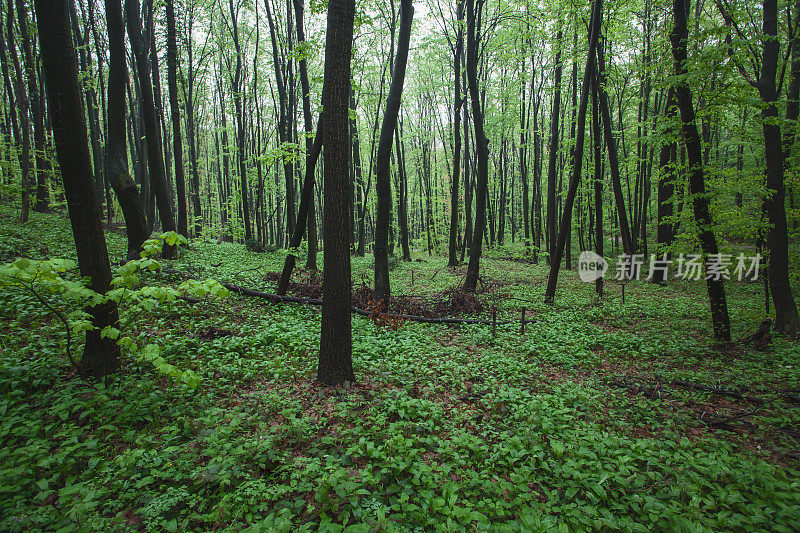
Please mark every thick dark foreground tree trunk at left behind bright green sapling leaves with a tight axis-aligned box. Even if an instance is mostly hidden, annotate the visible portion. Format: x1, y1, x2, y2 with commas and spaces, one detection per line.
35, 0, 119, 377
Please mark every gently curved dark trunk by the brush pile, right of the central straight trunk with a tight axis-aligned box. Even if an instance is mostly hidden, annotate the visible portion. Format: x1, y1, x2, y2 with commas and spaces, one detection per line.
374, 0, 414, 307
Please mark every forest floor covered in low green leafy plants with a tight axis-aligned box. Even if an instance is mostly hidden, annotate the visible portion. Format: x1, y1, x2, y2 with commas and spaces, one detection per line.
0, 207, 800, 532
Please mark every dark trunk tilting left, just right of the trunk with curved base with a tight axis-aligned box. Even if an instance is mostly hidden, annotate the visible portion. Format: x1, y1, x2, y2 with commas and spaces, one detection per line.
125, 0, 175, 259
